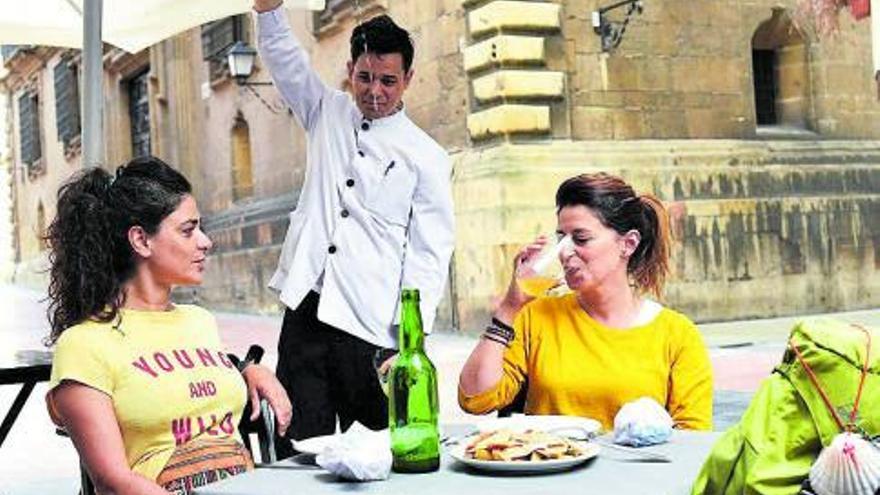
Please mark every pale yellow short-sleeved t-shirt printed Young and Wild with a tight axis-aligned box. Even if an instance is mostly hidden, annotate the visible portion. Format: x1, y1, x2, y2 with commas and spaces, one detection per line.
49, 305, 247, 480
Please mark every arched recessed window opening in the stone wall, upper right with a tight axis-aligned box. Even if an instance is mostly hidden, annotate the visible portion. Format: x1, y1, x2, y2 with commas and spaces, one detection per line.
752, 8, 810, 129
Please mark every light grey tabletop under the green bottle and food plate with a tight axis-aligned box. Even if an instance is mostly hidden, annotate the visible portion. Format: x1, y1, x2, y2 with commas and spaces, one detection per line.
196, 427, 721, 495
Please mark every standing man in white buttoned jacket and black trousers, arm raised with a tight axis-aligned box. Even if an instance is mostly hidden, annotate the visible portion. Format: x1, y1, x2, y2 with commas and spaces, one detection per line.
254, 0, 454, 451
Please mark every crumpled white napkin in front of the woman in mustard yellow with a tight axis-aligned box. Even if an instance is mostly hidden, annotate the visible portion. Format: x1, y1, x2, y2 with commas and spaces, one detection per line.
614, 397, 675, 447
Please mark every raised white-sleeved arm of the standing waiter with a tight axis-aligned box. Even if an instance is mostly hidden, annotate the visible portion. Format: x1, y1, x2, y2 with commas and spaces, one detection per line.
254, 0, 330, 130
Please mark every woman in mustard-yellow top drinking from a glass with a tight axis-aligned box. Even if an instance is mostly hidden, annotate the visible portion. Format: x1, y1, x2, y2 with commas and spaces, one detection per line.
459, 174, 712, 430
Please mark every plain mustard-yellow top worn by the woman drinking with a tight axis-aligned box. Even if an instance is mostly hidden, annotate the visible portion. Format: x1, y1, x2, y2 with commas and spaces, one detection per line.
459, 294, 712, 430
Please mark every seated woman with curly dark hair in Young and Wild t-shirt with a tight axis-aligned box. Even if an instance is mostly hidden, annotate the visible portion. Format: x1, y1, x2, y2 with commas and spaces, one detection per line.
46, 157, 290, 494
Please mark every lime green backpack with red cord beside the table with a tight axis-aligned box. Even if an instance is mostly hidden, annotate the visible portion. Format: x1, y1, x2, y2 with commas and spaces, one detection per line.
691, 318, 880, 495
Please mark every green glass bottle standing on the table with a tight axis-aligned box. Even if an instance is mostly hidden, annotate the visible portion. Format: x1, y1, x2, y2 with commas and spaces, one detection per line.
388, 289, 440, 473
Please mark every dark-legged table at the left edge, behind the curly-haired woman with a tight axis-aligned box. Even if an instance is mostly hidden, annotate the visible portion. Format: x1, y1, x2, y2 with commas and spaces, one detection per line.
0, 350, 52, 446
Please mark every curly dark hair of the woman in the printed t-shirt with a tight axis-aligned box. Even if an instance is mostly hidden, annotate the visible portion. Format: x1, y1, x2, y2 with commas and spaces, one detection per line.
45, 156, 192, 344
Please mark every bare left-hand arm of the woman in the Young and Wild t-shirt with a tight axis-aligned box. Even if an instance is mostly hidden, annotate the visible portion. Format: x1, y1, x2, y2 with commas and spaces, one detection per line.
49, 380, 168, 495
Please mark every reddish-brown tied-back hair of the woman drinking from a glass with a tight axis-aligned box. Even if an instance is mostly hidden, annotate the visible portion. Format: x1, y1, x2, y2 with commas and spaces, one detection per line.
556, 173, 672, 298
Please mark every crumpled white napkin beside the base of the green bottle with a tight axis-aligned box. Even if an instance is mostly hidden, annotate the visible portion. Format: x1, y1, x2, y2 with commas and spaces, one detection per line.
315, 422, 391, 481
